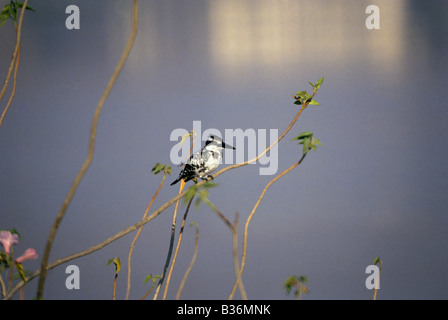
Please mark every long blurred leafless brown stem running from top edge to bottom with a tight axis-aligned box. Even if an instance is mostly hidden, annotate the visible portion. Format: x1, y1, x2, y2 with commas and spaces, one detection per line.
36, 0, 138, 299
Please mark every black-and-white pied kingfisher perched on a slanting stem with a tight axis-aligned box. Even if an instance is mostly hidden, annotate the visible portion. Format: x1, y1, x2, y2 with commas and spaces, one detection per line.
171, 136, 235, 185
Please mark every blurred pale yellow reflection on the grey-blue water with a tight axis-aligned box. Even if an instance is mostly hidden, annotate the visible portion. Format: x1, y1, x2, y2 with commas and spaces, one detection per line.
209, 0, 405, 76
